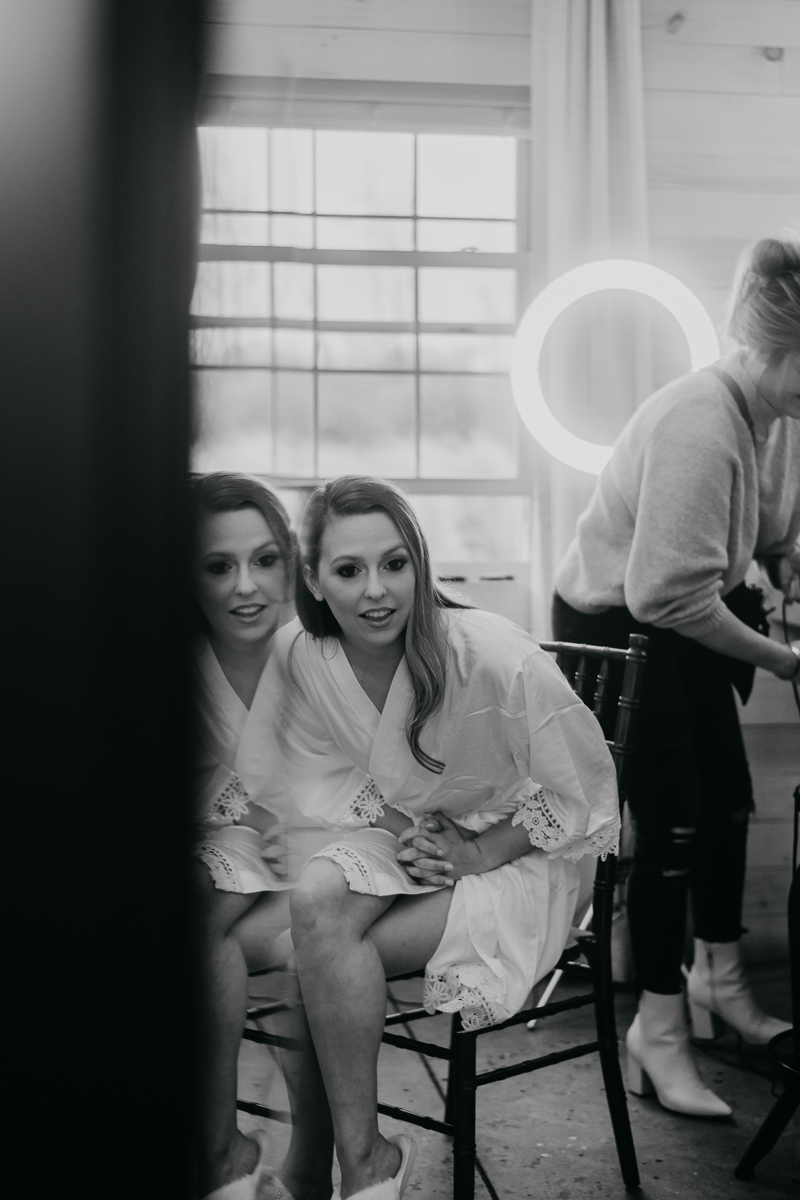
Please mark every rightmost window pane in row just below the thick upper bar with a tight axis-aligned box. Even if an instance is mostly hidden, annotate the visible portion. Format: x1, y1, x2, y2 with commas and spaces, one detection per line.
420, 266, 517, 325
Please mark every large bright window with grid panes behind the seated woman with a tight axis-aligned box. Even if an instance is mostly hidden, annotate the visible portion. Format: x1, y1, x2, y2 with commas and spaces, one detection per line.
192, 127, 528, 559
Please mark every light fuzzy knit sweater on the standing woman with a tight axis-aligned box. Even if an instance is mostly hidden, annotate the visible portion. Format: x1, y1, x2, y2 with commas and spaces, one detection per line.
555, 352, 800, 637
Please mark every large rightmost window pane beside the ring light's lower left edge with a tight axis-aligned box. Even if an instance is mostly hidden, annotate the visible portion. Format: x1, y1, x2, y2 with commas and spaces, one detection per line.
420, 376, 517, 479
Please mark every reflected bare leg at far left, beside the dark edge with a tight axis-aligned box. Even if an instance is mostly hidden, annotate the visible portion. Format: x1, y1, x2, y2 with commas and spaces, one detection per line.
196, 864, 288, 1196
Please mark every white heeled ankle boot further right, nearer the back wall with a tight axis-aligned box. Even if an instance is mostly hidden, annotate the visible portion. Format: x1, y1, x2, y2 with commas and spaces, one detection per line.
687, 937, 792, 1046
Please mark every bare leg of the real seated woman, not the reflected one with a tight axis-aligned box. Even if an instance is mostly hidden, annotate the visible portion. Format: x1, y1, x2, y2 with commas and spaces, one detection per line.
291, 858, 452, 1200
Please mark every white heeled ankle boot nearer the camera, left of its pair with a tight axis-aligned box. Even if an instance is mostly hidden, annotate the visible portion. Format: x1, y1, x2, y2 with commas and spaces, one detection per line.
625, 991, 732, 1117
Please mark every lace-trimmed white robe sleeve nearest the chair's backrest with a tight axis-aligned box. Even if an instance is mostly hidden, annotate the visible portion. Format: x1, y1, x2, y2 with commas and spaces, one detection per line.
510, 652, 620, 859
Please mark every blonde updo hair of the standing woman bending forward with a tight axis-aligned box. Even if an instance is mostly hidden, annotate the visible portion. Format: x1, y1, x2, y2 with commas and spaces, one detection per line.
727, 235, 800, 365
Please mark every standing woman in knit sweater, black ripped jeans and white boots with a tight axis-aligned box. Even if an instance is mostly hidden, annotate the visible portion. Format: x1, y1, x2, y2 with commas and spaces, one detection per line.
553, 239, 800, 1116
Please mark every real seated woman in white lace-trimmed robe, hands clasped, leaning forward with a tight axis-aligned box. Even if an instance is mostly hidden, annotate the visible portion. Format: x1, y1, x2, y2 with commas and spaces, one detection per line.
263, 478, 619, 1200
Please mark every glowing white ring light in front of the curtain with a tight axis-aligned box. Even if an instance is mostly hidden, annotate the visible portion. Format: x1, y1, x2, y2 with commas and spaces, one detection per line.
511, 258, 720, 475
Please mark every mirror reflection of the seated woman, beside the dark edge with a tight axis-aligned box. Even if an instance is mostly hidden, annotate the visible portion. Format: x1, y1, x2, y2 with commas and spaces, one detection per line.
192, 474, 330, 1200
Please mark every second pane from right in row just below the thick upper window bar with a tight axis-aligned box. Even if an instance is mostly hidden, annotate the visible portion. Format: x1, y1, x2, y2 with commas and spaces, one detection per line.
317, 266, 414, 320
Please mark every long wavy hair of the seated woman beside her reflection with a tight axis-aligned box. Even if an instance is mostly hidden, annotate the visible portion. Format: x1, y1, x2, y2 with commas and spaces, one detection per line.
295, 475, 469, 774
